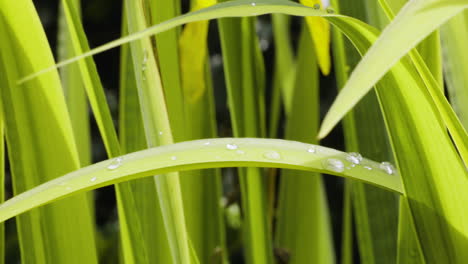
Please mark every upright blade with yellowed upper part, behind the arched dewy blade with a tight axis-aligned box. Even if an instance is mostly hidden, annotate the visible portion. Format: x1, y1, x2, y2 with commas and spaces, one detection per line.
176, 0, 228, 263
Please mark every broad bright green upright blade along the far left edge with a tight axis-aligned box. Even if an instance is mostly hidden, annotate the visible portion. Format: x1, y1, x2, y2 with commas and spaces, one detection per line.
0, 1, 97, 263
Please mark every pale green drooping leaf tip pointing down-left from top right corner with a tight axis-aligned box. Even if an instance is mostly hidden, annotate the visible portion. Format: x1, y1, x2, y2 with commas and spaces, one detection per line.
319, 0, 468, 138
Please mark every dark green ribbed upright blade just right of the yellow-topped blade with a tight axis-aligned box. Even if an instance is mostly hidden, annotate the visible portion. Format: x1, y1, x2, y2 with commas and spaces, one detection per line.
219, 8, 273, 263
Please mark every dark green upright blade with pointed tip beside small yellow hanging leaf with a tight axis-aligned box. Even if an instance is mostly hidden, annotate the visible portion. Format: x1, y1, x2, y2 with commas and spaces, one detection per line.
275, 25, 335, 264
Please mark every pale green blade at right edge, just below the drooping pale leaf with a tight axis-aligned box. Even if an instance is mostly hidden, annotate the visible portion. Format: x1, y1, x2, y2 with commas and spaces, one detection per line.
441, 11, 468, 129
